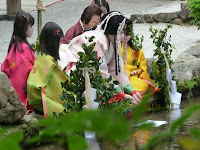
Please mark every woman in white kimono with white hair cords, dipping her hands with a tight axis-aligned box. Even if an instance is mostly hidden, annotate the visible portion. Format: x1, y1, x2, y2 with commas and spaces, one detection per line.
58, 11, 141, 104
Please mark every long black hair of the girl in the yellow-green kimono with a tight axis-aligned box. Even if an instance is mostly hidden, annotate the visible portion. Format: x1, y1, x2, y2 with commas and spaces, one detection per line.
39, 22, 64, 61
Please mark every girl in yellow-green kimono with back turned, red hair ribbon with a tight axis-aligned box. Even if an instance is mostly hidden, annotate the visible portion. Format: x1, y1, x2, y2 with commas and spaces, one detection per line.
27, 22, 67, 118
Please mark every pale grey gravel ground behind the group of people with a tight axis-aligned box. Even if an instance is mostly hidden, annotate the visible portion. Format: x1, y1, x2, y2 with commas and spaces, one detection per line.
0, 0, 200, 62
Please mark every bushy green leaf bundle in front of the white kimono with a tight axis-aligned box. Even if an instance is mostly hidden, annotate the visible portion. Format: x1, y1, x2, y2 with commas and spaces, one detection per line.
60, 36, 132, 114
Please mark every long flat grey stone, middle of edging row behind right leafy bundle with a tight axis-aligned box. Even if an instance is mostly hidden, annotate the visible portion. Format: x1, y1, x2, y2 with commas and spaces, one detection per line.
153, 12, 178, 23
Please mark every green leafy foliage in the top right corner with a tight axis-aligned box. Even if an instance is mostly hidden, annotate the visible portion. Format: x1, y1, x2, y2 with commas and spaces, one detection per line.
187, 0, 200, 30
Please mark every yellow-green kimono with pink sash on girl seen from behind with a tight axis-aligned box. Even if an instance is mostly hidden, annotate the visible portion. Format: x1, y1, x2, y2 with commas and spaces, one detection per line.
27, 54, 66, 117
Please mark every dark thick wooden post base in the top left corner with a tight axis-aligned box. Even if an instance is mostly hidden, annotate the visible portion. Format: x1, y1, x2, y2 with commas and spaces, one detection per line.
6, 0, 21, 15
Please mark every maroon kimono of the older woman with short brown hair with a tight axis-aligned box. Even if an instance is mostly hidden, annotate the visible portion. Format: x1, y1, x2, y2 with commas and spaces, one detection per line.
61, 20, 84, 44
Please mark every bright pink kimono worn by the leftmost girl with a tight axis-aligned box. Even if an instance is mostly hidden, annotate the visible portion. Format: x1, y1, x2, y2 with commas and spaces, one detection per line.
1, 42, 36, 113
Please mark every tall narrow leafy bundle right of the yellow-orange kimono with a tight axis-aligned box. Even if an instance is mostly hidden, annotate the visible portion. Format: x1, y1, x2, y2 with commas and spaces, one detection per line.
149, 25, 173, 106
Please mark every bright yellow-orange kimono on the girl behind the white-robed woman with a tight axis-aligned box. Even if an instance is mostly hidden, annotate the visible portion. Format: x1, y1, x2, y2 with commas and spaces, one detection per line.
121, 44, 155, 94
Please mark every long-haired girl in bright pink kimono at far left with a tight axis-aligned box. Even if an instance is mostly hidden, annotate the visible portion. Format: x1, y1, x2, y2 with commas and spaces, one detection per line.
1, 11, 36, 114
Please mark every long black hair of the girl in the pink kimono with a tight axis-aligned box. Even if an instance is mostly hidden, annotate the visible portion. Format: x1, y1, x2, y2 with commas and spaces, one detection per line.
8, 11, 34, 53
